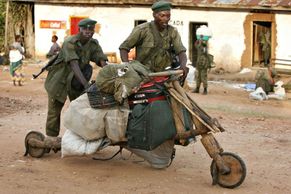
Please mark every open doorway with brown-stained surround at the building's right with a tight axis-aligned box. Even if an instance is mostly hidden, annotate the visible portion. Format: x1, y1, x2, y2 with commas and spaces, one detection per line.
252, 21, 273, 66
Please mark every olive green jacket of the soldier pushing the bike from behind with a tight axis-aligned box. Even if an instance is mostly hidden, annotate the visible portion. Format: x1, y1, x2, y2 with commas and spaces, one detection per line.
45, 34, 107, 102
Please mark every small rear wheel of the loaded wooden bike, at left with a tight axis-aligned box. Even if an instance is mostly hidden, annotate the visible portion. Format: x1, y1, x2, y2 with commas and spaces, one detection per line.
24, 131, 46, 158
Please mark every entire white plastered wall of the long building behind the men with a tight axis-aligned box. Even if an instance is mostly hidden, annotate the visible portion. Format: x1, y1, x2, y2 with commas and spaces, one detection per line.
35, 5, 280, 72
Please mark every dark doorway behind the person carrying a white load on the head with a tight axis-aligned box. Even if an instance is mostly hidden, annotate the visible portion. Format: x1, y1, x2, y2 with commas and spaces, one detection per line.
189, 22, 208, 67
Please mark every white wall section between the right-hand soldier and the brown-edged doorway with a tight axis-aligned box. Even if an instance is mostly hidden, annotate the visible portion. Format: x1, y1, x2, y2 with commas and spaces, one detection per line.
172, 10, 247, 71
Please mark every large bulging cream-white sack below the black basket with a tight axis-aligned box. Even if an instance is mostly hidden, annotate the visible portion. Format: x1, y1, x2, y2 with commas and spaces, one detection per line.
64, 93, 108, 140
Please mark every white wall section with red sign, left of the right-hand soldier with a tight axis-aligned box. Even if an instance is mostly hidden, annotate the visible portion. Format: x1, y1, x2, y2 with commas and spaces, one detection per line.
35, 5, 152, 56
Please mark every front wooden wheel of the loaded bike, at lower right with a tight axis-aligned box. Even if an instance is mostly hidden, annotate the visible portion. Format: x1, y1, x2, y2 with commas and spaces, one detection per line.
210, 152, 247, 189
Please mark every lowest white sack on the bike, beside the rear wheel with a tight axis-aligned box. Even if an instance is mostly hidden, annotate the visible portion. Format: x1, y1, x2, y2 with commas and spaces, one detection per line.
61, 130, 110, 157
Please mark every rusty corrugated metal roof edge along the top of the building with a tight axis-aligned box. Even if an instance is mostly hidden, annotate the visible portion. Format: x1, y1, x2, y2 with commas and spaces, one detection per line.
12, 0, 291, 12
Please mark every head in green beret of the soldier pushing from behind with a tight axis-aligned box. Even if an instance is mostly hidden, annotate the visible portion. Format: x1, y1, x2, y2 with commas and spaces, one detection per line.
78, 18, 97, 42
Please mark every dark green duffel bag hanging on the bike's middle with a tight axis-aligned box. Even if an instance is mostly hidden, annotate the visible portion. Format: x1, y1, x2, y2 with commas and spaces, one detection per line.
127, 100, 176, 151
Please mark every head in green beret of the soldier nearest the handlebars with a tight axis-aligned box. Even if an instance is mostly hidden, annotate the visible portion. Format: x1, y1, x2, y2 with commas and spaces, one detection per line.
152, 0, 172, 31
